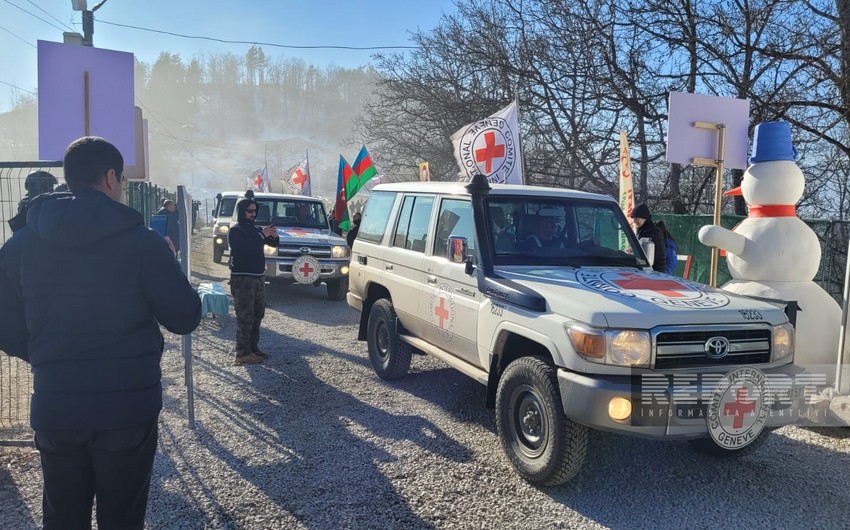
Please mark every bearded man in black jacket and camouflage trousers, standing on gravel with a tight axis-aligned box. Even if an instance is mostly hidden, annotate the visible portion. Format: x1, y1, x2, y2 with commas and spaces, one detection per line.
227, 197, 279, 366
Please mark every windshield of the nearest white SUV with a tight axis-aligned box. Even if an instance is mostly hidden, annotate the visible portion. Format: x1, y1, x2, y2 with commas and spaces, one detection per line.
487, 196, 647, 267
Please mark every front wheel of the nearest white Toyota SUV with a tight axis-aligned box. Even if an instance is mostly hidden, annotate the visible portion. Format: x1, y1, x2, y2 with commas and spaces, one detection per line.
496, 357, 588, 486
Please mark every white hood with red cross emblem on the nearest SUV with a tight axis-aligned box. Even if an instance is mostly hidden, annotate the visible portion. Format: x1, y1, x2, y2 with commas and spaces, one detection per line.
496, 267, 787, 329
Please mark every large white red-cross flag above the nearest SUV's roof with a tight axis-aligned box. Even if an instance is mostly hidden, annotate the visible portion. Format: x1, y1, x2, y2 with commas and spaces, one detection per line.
452, 102, 523, 184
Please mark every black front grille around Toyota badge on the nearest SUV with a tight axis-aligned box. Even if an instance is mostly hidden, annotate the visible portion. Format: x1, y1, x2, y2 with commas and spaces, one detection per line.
655, 328, 771, 370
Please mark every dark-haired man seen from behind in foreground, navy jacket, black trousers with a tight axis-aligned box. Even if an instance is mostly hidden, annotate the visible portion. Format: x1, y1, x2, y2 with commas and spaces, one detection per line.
0, 137, 201, 529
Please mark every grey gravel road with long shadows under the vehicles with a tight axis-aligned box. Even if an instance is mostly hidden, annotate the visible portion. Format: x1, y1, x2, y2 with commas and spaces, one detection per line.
0, 229, 850, 530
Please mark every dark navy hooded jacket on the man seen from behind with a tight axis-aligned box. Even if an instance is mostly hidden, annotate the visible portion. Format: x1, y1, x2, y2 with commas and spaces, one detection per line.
0, 191, 201, 430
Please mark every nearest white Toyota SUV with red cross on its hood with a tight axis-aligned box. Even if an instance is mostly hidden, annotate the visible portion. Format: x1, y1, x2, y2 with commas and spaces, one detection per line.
347, 176, 810, 485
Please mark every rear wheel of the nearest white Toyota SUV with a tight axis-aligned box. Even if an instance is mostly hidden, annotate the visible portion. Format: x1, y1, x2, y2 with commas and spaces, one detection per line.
366, 298, 413, 381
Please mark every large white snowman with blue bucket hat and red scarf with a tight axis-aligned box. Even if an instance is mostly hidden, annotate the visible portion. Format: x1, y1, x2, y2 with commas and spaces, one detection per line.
699, 121, 841, 384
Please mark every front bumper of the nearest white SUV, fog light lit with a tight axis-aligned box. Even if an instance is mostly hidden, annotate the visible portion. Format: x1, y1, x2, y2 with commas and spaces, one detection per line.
558, 364, 814, 440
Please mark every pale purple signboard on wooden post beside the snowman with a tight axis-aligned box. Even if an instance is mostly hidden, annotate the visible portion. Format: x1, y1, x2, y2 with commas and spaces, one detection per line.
667, 92, 750, 169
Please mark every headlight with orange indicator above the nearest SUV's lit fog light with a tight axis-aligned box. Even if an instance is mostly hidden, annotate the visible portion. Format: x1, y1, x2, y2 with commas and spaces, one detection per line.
564, 322, 652, 366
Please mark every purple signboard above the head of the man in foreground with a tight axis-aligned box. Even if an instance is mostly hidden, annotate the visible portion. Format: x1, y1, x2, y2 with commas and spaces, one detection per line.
38, 40, 136, 165
